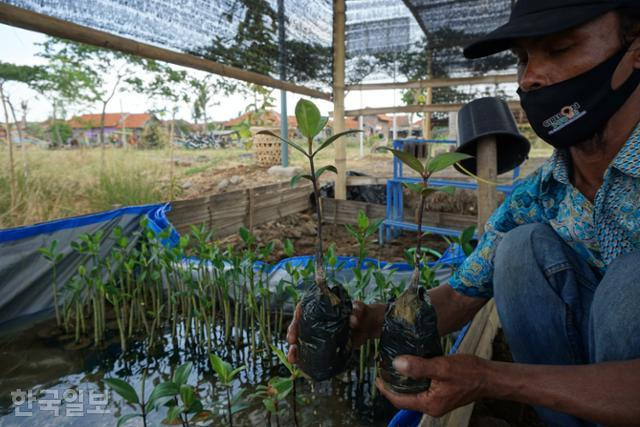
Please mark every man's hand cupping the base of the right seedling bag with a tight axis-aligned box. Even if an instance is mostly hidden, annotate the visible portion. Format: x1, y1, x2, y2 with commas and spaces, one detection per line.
376, 354, 488, 417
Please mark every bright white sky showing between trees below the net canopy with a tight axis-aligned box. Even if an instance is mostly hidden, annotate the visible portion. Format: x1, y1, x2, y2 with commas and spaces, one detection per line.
0, 24, 400, 121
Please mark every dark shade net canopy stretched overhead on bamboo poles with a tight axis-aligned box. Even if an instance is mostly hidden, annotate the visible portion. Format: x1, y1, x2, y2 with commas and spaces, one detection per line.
0, 0, 514, 90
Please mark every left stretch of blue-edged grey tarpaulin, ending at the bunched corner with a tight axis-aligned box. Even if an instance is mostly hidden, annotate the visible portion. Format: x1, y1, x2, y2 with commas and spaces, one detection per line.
0, 204, 177, 328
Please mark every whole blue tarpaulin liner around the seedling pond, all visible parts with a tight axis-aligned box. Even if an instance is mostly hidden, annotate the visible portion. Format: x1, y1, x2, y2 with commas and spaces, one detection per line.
0, 203, 466, 427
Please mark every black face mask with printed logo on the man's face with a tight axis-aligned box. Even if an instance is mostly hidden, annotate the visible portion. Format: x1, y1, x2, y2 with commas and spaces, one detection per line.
518, 48, 640, 149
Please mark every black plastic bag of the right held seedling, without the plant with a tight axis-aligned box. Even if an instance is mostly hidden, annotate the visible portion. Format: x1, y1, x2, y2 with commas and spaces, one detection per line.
380, 287, 442, 393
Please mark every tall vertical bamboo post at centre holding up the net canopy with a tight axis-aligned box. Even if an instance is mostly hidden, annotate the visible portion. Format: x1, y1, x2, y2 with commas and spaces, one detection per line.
333, 0, 347, 200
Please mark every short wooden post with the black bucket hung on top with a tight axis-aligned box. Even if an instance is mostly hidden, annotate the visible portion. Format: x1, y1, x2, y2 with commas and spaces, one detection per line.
476, 137, 498, 235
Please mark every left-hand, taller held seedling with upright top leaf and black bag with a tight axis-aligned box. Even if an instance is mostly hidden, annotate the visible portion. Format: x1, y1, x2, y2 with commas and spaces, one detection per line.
259, 100, 359, 381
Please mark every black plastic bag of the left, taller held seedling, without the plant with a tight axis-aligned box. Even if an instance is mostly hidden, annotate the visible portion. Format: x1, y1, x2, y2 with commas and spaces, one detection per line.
298, 285, 352, 381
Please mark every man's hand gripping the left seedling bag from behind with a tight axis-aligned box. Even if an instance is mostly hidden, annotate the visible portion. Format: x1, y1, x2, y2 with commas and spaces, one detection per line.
287, 301, 385, 363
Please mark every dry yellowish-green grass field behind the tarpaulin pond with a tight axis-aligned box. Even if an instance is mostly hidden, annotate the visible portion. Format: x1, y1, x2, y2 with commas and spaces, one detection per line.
0, 140, 376, 228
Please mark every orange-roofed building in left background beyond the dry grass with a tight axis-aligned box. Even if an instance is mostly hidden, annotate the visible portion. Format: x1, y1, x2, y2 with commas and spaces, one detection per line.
68, 113, 158, 144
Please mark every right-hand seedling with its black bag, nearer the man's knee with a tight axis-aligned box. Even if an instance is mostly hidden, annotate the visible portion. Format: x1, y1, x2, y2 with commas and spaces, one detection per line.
380, 147, 470, 393
